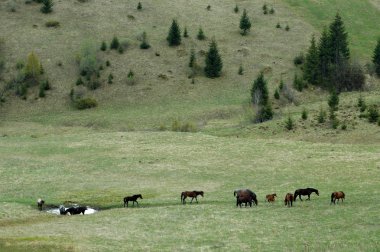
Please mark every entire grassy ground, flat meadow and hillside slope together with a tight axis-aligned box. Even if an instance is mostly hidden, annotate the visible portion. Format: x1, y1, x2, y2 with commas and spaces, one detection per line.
0, 0, 380, 251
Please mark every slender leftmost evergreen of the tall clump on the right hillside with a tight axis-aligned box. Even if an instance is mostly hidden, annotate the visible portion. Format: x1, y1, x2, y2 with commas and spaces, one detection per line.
303, 35, 320, 85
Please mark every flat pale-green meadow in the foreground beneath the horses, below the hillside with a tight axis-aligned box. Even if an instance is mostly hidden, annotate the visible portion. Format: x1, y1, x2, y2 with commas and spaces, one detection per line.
0, 128, 380, 251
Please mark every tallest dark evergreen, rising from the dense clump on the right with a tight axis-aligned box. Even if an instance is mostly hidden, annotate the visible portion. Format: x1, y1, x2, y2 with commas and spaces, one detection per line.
329, 13, 350, 66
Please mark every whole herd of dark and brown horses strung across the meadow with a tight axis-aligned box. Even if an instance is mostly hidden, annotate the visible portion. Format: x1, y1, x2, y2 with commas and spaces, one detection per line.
37, 187, 345, 215
